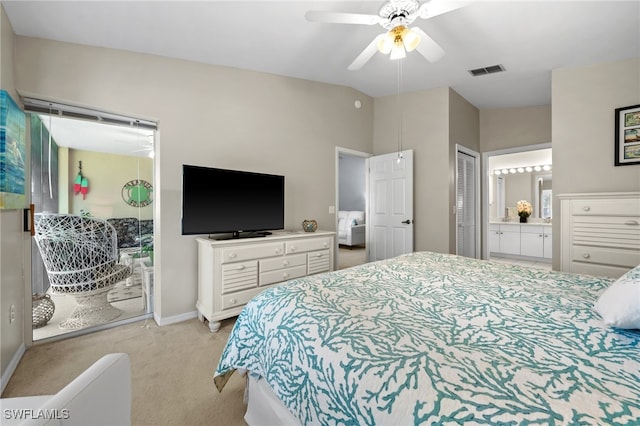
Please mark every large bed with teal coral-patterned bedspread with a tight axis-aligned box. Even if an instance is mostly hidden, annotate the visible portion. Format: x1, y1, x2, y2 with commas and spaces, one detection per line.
214, 252, 640, 425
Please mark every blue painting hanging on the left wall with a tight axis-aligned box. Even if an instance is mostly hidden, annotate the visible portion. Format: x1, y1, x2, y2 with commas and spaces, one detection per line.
0, 90, 27, 209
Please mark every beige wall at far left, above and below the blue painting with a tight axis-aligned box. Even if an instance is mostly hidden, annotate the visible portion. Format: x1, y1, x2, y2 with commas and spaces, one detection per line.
0, 7, 31, 389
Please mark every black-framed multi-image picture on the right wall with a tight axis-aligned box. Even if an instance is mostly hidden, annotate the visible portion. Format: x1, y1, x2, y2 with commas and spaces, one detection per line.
615, 105, 640, 166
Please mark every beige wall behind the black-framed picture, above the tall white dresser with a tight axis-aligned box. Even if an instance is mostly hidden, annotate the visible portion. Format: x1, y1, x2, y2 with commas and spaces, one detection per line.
551, 58, 640, 268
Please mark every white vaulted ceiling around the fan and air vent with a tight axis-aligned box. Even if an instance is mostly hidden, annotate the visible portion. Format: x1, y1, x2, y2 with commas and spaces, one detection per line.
2, 0, 640, 109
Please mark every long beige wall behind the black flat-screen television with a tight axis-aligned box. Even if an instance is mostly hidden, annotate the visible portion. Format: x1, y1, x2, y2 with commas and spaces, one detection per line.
15, 37, 373, 323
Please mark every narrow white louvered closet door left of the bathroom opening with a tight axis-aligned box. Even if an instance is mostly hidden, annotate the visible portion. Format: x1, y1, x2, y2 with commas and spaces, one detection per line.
456, 146, 480, 258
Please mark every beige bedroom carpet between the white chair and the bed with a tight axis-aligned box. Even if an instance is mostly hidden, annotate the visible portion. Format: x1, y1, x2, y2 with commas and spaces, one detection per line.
2, 318, 246, 426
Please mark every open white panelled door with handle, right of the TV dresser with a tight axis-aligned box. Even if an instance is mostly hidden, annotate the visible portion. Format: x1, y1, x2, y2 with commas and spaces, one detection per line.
367, 150, 413, 261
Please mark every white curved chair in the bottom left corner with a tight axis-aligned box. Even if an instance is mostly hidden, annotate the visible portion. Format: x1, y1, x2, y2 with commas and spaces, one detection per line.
0, 353, 131, 426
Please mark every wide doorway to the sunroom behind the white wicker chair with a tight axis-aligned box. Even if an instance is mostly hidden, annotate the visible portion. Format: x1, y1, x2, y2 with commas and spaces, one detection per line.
25, 99, 156, 341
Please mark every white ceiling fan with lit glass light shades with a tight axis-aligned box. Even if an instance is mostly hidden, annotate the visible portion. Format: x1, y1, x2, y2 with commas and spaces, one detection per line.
305, 0, 465, 71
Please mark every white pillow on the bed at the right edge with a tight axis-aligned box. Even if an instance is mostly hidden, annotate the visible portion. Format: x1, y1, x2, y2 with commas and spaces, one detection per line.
595, 265, 640, 329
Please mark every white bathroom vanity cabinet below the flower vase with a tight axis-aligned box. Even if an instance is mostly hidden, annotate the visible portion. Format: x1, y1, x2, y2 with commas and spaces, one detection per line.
489, 222, 553, 260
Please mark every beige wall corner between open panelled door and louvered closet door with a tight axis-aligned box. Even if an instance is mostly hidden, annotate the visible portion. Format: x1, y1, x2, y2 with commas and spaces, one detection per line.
373, 87, 479, 253
